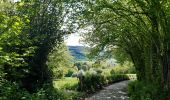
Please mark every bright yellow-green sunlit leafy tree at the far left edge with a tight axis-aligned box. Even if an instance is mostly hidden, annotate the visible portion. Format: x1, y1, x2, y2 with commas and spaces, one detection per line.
0, 1, 35, 82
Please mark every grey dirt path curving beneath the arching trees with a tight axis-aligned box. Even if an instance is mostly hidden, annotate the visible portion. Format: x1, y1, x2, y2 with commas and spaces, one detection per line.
85, 81, 130, 100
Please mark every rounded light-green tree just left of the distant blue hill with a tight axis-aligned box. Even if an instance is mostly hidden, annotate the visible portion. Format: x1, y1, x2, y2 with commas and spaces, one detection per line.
47, 43, 73, 78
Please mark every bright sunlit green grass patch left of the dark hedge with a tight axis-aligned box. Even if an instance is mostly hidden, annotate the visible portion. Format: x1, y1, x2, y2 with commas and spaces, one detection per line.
53, 77, 78, 90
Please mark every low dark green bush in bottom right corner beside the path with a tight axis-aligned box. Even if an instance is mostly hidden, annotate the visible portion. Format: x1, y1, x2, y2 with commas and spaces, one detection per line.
128, 81, 170, 100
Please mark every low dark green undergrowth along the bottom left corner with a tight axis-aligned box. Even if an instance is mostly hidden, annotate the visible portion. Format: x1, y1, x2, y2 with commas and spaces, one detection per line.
0, 80, 67, 100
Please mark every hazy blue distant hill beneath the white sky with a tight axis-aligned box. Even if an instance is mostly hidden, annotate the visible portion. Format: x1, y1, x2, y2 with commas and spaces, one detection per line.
68, 46, 87, 61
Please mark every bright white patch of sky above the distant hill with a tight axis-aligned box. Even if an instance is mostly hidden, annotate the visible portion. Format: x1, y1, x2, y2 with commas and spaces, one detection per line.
65, 34, 83, 46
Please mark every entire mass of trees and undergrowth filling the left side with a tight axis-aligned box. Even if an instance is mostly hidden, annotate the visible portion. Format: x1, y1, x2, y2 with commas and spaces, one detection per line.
0, 0, 73, 100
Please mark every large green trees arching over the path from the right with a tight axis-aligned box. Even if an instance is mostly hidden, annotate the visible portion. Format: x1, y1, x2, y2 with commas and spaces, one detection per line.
77, 0, 170, 89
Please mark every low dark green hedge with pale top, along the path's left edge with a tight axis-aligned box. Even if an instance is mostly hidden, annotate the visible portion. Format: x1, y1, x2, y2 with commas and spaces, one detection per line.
78, 70, 129, 93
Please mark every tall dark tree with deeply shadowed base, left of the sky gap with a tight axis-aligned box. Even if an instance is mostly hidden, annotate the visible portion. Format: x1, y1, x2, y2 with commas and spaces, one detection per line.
18, 0, 72, 91
